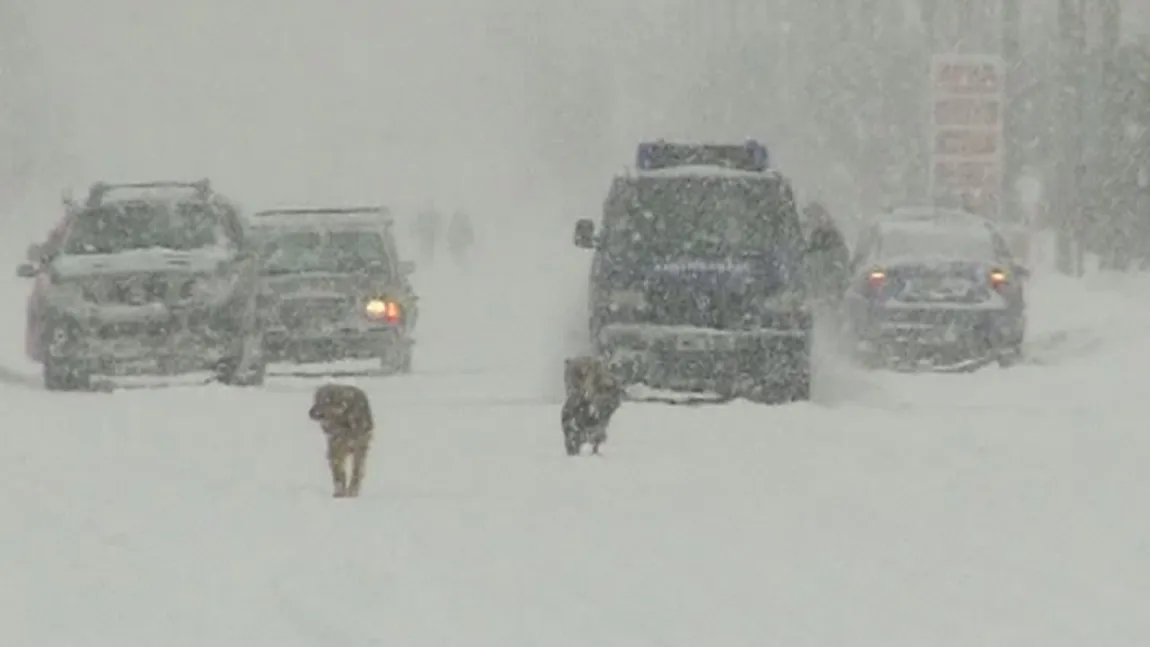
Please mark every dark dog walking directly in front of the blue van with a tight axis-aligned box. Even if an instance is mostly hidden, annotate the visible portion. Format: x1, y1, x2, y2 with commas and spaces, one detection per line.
560, 356, 623, 456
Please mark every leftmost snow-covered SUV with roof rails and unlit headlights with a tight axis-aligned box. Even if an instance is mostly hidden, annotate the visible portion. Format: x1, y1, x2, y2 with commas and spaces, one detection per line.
17, 180, 263, 390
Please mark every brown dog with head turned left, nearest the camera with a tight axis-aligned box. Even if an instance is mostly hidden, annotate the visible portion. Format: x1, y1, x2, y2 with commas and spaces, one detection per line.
307, 384, 375, 498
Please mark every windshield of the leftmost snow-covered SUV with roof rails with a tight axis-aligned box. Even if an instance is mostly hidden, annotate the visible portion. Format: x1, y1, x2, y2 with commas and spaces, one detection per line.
63, 202, 228, 255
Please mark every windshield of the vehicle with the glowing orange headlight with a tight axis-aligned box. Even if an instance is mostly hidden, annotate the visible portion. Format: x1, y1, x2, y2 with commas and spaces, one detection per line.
262, 231, 388, 275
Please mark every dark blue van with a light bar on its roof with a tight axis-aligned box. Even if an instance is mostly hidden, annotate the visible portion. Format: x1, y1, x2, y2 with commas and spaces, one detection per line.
575, 141, 812, 401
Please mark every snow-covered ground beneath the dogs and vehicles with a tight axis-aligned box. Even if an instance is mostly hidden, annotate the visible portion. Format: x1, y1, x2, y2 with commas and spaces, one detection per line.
0, 231, 1150, 647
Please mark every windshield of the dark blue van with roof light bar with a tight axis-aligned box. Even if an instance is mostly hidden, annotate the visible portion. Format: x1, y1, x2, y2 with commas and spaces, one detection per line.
604, 176, 802, 257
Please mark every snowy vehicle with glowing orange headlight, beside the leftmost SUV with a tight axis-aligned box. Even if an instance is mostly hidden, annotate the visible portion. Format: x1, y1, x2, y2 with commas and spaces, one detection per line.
251, 207, 419, 372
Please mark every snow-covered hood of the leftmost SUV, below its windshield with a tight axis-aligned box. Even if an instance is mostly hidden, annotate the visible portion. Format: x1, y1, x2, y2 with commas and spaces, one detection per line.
52, 249, 232, 278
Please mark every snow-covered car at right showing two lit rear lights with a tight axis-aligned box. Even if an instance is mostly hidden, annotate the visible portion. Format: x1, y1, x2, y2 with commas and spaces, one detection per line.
844, 209, 1029, 365
